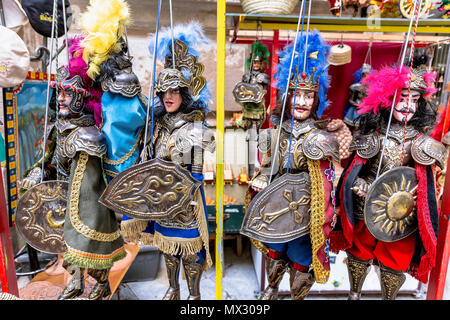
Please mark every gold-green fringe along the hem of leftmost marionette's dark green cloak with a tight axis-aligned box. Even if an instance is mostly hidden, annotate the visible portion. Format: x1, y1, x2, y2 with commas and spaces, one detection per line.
63, 247, 127, 270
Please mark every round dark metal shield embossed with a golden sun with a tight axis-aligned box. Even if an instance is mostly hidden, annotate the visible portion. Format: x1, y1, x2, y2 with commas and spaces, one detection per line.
364, 167, 418, 242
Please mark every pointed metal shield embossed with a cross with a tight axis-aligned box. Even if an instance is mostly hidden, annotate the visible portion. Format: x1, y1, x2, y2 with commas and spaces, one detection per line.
241, 172, 311, 243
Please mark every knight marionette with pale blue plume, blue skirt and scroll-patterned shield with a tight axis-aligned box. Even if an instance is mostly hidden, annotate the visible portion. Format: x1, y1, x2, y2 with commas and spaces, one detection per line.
102, 23, 215, 300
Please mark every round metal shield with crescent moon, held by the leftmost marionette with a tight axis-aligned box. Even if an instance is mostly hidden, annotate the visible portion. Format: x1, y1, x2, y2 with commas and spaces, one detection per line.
15, 180, 69, 254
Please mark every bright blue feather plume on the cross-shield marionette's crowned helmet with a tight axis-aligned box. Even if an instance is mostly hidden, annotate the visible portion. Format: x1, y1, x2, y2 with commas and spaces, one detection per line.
274, 30, 330, 117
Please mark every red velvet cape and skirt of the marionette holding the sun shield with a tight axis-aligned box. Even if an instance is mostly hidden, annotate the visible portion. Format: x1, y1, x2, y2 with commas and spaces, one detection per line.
330, 153, 439, 283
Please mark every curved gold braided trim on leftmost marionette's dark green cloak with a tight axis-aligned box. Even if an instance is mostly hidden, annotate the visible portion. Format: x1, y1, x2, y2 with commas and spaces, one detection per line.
69, 152, 120, 242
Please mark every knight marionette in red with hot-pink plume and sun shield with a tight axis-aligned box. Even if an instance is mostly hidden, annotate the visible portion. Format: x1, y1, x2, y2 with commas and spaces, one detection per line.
331, 60, 445, 300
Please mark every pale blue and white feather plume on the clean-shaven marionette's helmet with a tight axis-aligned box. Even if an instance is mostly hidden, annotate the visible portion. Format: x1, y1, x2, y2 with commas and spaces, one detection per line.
148, 21, 212, 113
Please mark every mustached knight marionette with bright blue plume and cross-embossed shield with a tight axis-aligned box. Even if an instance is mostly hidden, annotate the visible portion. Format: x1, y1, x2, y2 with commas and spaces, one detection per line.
241, 32, 339, 299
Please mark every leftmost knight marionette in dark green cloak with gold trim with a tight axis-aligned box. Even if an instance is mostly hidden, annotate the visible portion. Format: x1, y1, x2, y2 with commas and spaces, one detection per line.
18, 38, 126, 300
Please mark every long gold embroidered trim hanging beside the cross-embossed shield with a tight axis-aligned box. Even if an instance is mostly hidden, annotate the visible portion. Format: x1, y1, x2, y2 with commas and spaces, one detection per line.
307, 158, 330, 283
